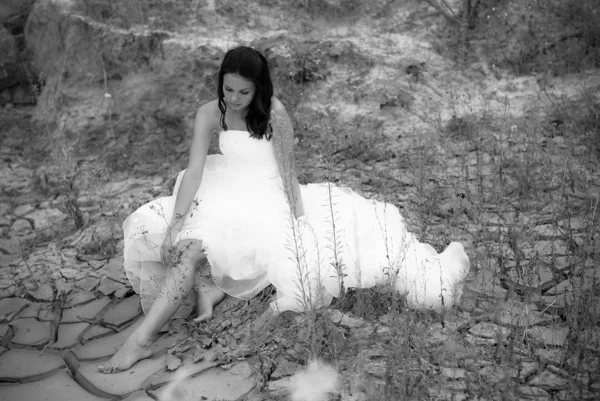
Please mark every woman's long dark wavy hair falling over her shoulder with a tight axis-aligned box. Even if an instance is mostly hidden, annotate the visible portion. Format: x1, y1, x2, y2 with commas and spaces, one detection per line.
217, 46, 273, 140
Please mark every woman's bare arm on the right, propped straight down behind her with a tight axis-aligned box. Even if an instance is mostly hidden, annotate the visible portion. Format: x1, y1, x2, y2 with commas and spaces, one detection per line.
271, 98, 304, 218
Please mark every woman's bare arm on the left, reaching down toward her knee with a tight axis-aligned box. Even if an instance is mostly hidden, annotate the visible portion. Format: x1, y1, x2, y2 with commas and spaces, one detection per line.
169, 104, 214, 234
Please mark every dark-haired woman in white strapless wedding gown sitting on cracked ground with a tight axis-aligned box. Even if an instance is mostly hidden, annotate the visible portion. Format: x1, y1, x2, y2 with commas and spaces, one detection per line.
99, 46, 469, 373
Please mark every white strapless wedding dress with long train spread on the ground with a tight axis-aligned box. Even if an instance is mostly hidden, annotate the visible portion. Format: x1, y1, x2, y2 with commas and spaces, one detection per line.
123, 130, 469, 314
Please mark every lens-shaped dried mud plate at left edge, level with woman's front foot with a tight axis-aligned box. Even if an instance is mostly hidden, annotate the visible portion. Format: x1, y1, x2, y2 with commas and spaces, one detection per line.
0, 348, 65, 382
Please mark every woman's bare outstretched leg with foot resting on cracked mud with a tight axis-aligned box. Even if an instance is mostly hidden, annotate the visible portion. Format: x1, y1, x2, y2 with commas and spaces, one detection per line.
99, 240, 206, 373
